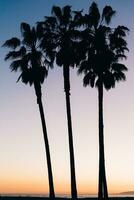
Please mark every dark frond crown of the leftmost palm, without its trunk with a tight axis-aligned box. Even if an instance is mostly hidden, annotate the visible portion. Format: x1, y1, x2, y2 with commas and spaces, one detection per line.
3, 23, 48, 86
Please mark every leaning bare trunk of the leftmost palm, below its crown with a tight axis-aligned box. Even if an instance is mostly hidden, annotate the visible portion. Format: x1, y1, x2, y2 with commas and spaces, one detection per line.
34, 83, 55, 199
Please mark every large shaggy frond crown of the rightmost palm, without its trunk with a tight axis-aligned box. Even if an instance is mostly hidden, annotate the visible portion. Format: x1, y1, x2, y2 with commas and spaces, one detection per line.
78, 3, 128, 90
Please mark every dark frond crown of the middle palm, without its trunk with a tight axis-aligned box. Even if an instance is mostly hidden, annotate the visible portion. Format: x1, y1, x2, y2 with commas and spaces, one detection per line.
39, 5, 79, 69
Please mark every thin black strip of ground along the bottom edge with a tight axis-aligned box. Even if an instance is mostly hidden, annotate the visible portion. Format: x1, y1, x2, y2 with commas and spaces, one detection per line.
0, 196, 134, 200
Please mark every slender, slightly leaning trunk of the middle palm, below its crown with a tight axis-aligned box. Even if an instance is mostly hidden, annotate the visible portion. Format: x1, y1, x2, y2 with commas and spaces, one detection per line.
63, 66, 77, 199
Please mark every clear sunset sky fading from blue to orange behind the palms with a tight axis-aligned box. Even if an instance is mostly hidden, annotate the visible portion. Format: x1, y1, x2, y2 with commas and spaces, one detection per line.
0, 0, 134, 194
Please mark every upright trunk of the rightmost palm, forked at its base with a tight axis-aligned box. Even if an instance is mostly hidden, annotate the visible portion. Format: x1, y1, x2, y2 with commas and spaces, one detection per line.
98, 83, 108, 199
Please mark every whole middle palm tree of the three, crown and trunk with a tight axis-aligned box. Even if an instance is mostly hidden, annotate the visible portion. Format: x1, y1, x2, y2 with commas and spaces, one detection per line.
40, 5, 78, 199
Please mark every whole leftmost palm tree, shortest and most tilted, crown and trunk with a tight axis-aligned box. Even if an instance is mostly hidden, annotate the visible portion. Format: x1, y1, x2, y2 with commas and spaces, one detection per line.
3, 23, 55, 198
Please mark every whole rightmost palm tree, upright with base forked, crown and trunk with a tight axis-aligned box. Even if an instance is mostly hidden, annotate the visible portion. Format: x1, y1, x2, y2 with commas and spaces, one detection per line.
78, 2, 128, 199
